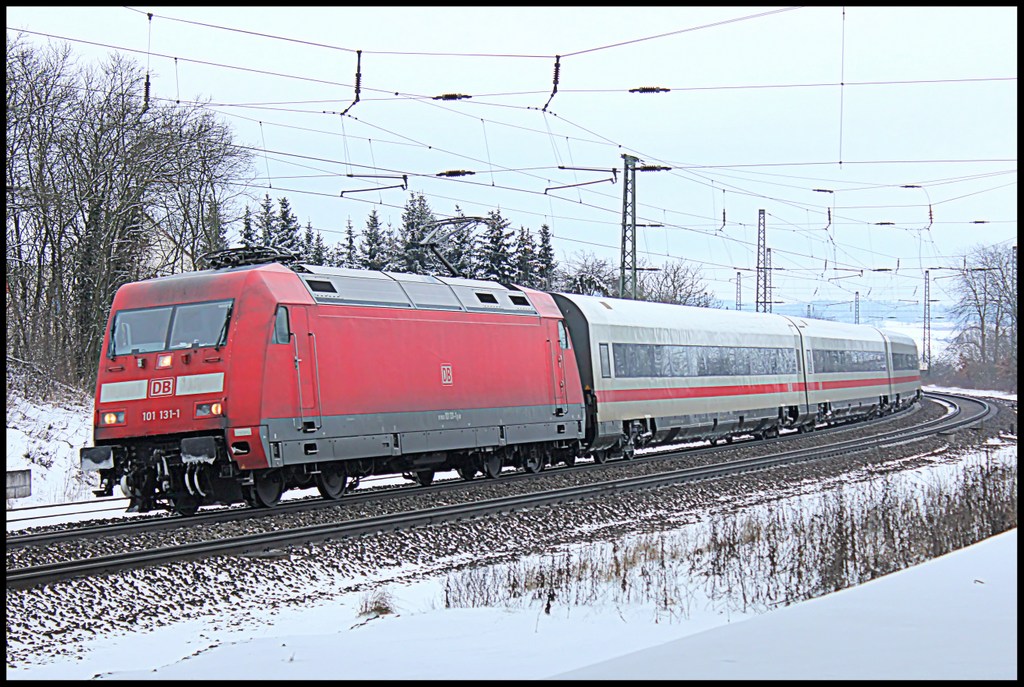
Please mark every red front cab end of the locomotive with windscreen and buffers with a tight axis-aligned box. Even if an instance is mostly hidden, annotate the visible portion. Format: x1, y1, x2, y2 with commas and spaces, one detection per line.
80, 265, 311, 514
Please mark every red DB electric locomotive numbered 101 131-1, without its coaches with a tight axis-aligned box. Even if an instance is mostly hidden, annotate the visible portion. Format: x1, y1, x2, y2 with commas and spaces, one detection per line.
81, 249, 584, 514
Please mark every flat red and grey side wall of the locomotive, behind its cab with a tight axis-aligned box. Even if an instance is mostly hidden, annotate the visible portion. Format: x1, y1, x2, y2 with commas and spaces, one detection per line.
261, 278, 583, 467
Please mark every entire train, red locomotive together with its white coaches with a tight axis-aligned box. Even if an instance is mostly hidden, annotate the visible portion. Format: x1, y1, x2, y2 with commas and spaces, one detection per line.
81, 250, 921, 514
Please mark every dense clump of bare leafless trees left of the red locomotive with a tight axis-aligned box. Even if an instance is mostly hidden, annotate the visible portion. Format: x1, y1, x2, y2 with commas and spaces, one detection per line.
6, 36, 256, 393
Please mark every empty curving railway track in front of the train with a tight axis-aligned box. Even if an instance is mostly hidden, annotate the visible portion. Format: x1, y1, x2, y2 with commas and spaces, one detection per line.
7, 393, 996, 588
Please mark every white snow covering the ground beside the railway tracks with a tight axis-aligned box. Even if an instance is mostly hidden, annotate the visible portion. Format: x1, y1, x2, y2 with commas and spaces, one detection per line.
7, 387, 1017, 680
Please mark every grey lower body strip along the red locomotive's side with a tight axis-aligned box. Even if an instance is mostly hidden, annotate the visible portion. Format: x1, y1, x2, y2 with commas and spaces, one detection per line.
263, 405, 584, 467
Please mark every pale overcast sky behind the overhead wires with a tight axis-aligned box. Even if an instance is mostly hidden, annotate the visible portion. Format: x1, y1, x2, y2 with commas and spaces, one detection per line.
7, 6, 1018, 319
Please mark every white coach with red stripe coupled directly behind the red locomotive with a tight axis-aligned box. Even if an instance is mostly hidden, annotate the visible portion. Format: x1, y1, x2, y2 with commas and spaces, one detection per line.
555, 294, 814, 460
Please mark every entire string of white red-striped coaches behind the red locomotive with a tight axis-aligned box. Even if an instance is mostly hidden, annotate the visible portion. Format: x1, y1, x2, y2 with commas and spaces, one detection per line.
554, 294, 921, 460
